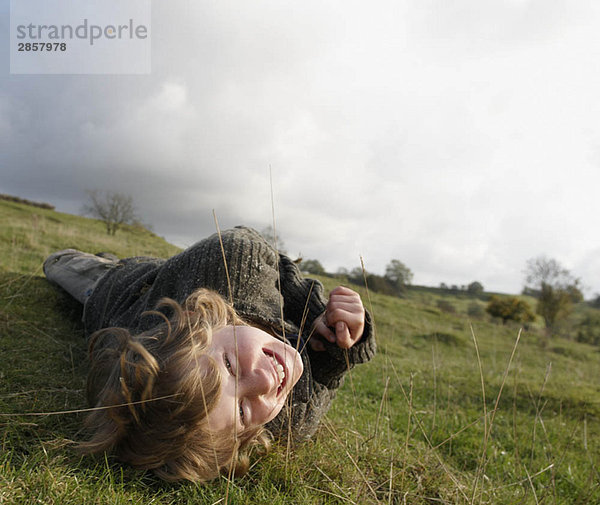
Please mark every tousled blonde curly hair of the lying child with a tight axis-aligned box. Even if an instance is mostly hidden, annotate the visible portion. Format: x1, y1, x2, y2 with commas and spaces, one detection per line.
79, 289, 269, 482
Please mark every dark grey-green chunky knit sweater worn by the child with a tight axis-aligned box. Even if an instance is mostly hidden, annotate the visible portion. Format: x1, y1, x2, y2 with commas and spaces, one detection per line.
84, 227, 375, 440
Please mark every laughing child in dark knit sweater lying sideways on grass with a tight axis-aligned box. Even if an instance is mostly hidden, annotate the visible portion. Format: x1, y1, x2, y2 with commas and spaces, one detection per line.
44, 227, 375, 481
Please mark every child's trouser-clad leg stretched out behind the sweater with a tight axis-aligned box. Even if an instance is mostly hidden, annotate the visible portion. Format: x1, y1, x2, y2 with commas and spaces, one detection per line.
44, 249, 116, 303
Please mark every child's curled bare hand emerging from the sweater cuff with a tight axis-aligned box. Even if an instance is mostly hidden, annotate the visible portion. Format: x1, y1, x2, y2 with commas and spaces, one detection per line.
310, 286, 365, 351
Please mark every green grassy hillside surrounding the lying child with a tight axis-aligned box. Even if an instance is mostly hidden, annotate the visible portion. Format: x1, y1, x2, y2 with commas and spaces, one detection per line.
0, 202, 600, 505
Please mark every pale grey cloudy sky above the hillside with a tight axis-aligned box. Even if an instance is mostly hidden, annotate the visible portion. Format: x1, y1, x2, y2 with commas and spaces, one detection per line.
0, 0, 600, 296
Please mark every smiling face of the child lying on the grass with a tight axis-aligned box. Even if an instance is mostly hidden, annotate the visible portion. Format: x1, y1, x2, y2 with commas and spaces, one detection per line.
208, 326, 303, 433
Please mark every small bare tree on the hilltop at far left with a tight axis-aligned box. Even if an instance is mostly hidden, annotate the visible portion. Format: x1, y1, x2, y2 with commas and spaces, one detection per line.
83, 190, 136, 235
